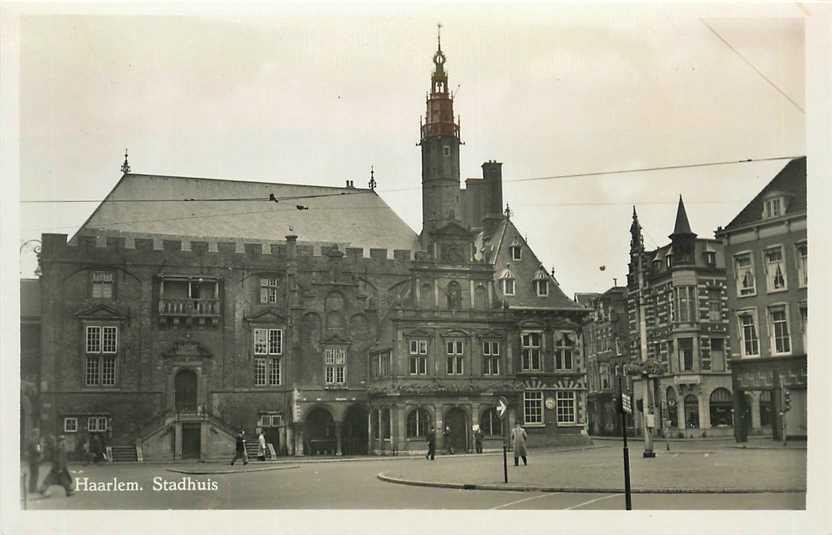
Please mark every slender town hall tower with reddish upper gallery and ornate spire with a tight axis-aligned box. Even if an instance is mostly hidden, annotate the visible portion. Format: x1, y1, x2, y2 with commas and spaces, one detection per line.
419, 26, 462, 241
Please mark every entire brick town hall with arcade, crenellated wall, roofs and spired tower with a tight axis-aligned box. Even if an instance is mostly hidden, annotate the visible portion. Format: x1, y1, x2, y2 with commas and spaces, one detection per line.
35, 36, 588, 460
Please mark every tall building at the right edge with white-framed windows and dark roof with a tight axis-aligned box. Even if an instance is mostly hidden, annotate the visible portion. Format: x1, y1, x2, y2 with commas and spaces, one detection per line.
717, 157, 809, 441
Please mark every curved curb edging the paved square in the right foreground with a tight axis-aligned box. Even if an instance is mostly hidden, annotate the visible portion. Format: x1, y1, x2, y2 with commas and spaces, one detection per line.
376, 472, 806, 494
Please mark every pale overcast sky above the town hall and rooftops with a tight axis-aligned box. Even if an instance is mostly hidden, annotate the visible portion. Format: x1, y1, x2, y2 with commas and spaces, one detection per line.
14, 4, 812, 296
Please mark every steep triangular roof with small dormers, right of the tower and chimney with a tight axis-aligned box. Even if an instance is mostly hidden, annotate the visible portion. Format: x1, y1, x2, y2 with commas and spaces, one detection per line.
476, 218, 584, 310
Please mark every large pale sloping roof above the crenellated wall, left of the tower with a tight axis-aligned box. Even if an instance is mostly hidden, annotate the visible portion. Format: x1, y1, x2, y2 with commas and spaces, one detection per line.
73, 174, 417, 250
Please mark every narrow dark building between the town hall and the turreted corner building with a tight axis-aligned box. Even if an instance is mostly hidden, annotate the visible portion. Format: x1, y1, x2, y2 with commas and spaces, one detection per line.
581, 286, 633, 436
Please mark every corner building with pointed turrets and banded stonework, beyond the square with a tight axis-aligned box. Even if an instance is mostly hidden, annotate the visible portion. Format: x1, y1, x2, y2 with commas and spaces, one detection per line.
627, 197, 733, 437
